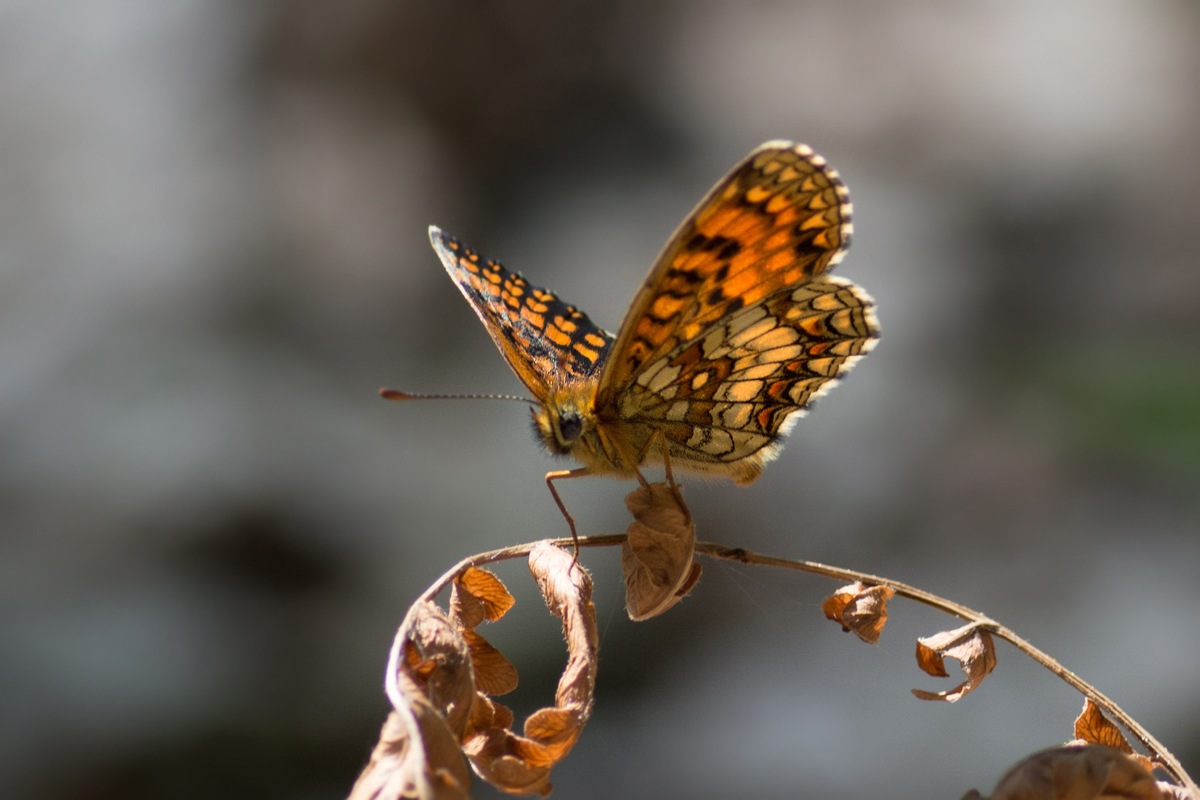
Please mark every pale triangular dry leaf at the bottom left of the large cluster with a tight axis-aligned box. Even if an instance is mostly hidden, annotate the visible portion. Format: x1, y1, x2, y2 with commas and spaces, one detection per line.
349, 675, 470, 800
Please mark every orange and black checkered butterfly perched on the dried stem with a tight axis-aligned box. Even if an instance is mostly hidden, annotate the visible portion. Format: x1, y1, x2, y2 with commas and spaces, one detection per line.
383, 142, 880, 541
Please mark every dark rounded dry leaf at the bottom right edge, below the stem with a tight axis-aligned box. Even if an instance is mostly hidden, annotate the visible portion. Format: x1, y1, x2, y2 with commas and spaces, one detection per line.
964, 745, 1166, 800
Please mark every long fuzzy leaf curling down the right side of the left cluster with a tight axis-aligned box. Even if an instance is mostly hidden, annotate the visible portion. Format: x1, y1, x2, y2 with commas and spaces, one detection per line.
463, 542, 599, 795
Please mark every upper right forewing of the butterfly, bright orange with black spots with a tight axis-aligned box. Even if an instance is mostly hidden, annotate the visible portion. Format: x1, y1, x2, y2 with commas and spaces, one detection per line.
598, 142, 851, 407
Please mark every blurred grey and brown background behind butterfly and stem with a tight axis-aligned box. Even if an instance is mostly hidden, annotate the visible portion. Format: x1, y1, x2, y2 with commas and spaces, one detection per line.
0, 0, 1200, 800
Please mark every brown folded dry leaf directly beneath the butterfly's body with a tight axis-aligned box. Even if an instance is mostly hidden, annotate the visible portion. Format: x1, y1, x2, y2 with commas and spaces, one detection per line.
620, 483, 701, 621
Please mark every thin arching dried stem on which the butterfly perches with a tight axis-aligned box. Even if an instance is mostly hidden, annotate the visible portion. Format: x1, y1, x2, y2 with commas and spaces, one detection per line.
386, 534, 1200, 796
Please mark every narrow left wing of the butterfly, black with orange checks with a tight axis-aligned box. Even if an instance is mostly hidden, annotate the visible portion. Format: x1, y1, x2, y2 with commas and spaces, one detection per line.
430, 225, 614, 402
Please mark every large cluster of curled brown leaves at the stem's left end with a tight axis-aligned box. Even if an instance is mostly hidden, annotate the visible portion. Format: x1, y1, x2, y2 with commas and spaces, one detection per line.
350, 542, 598, 800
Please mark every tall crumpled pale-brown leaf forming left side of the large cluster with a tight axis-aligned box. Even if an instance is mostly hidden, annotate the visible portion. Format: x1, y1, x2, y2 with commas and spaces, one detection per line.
350, 603, 475, 800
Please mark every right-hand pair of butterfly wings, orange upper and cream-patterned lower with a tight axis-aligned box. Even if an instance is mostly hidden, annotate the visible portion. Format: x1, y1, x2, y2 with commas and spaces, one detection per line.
596, 142, 878, 482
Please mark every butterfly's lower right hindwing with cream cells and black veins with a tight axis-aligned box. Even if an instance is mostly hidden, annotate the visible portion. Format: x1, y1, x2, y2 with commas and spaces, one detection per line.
618, 276, 878, 474
